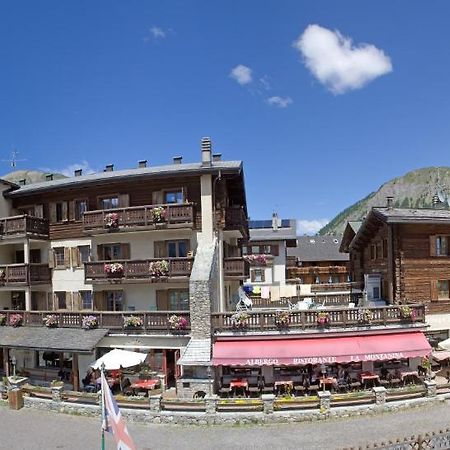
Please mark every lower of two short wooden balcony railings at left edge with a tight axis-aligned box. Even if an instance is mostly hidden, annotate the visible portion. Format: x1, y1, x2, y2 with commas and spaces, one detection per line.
0, 264, 52, 286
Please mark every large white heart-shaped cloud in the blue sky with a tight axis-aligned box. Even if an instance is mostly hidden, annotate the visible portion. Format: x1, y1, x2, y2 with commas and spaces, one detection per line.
293, 25, 392, 94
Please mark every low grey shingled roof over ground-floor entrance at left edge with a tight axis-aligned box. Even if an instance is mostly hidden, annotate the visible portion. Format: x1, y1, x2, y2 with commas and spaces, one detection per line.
0, 327, 108, 353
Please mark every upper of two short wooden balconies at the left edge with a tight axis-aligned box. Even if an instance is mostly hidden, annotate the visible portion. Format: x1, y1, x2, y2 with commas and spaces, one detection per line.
0, 214, 49, 239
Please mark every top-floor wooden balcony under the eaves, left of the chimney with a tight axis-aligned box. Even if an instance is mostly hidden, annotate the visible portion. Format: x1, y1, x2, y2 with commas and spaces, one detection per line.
83, 203, 195, 234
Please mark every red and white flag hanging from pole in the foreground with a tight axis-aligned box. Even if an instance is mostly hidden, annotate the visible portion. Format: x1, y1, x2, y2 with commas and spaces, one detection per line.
102, 372, 136, 450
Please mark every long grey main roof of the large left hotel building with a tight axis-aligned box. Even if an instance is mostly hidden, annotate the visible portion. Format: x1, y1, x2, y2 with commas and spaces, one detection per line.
8, 161, 242, 197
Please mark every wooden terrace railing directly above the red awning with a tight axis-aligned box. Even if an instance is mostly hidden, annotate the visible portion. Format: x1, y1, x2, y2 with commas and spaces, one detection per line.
211, 305, 425, 332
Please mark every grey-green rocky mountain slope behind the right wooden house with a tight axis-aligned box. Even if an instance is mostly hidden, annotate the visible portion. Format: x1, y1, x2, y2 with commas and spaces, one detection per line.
319, 167, 450, 234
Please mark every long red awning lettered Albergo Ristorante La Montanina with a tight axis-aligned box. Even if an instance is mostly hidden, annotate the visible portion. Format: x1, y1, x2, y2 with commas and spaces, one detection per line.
212, 331, 431, 366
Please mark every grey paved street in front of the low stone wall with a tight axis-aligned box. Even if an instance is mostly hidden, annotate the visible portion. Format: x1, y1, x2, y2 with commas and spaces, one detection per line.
0, 402, 450, 450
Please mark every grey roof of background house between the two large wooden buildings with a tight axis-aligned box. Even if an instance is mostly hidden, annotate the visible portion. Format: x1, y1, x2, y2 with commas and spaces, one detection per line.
288, 235, 349, 262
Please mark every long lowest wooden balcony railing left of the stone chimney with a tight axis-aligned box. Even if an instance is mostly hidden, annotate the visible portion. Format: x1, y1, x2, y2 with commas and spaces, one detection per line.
1, 310, 191, 333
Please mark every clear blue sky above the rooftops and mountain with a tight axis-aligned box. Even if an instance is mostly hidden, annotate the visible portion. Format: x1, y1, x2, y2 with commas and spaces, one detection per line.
0, 0, 450, 230
